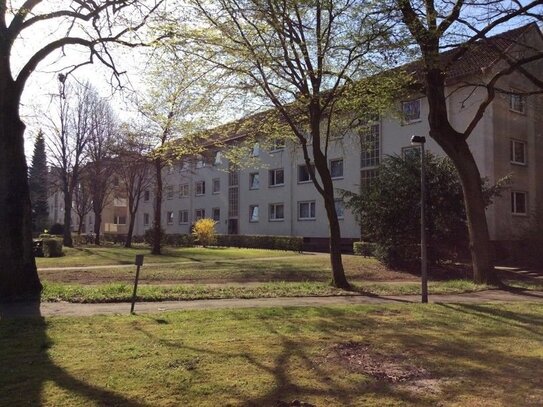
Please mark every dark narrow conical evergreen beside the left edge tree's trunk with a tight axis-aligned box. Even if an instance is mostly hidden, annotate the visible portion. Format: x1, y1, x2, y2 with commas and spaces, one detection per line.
28, 130, 49, 233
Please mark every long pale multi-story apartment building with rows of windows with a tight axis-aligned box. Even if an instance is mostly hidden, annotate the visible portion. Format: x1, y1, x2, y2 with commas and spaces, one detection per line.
131, 24, 543, 249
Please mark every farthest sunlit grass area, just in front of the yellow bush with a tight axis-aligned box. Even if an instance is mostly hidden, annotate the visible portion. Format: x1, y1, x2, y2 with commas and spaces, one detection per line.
36, 245, 298, 268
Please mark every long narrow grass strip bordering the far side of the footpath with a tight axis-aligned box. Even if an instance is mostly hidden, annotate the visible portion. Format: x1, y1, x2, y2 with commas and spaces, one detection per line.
42, 280, 491, 303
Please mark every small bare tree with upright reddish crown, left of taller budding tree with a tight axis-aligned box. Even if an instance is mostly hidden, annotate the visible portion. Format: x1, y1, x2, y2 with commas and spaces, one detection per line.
115, 131, 153, 247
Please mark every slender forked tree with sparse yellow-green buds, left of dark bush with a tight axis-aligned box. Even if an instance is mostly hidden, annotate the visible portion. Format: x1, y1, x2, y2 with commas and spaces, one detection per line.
172, 0, 406, 288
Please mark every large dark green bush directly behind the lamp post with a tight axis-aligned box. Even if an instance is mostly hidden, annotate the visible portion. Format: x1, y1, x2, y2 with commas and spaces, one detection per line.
344, 153, 499, 267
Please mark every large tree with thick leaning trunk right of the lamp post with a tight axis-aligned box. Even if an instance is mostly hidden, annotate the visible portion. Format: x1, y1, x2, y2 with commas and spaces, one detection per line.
389, 0, 543, 283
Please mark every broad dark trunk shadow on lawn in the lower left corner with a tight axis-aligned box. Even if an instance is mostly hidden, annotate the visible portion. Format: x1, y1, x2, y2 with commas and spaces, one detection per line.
0, 302, 149, 407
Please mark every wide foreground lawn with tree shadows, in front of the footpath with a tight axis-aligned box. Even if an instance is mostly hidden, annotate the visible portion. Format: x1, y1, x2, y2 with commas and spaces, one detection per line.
0, 304, 543, 406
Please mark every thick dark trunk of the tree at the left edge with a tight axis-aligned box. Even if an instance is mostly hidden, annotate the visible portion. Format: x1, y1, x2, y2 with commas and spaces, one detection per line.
0, 75, 42, 302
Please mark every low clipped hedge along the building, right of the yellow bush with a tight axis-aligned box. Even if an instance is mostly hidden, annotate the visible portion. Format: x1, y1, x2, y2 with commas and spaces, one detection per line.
215, 235, 304, 252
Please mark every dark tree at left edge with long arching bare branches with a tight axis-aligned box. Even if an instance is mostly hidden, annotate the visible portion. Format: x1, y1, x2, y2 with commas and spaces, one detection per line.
0, 0, 163, 300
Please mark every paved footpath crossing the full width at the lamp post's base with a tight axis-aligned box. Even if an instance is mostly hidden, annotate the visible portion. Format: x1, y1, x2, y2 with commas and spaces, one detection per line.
0, 290, 543, 317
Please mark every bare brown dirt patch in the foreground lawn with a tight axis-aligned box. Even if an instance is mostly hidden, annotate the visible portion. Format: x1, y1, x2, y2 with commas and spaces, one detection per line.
325, 342, 431, 383
